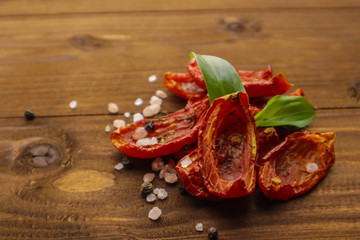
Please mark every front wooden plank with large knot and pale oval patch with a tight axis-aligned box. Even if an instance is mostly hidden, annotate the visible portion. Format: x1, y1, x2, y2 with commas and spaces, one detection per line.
0, 110, 360, 239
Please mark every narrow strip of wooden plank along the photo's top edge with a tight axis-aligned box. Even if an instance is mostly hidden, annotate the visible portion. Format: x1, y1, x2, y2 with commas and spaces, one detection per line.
0, 0, 360, 16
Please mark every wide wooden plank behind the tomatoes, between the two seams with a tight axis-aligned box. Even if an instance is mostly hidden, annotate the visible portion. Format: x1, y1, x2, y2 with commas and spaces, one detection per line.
0, 9, 360, 117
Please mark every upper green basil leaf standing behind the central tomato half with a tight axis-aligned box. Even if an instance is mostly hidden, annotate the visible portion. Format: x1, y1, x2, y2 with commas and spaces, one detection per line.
190, 52, 245, 102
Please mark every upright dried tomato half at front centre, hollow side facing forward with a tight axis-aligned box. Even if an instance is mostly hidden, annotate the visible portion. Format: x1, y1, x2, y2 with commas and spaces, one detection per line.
199, 92, 257, 198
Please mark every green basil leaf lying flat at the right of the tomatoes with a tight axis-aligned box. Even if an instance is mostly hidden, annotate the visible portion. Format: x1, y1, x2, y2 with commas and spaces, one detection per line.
255, 95, 315, 128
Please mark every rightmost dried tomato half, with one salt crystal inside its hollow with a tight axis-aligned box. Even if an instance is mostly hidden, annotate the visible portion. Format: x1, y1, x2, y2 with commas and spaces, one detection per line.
258, 132, 335, 200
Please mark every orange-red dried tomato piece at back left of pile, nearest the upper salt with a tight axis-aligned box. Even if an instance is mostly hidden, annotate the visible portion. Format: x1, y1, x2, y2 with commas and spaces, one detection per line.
163, 72, 206, 99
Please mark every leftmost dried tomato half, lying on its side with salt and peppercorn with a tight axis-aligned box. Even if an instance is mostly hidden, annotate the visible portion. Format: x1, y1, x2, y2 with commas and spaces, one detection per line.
110, 98, 209, 158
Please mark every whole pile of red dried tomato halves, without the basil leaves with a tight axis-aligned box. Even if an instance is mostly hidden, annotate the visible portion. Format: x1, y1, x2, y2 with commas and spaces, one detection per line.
111, 58, 335, 201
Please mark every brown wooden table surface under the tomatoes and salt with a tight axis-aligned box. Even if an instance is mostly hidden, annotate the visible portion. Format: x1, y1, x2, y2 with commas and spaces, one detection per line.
0, 0, 360, 239
